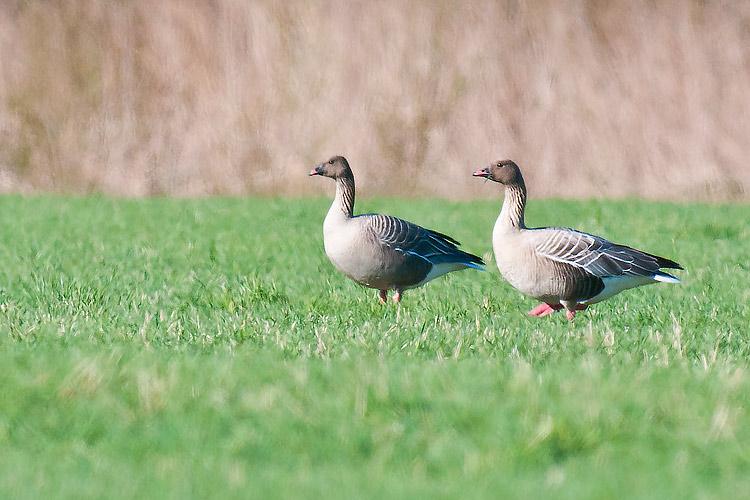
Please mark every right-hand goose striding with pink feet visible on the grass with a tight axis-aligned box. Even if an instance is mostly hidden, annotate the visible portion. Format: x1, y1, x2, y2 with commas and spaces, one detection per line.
473, 160, 682, 320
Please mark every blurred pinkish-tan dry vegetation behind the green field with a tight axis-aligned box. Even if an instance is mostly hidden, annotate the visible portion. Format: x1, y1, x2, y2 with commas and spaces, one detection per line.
0, 0, 750, 200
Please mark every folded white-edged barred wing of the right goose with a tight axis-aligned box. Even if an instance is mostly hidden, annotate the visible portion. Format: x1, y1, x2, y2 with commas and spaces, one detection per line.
535, 228, 682, 278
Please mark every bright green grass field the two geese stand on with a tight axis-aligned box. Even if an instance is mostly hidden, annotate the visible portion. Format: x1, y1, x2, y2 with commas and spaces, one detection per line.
0, 197, 750, 498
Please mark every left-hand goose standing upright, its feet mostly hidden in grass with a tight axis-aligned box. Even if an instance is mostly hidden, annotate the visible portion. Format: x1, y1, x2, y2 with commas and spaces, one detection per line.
310, 156, 484, 303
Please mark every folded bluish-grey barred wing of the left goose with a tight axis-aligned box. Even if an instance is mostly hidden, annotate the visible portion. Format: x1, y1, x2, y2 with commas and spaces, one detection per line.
361, 214, 484, 269
